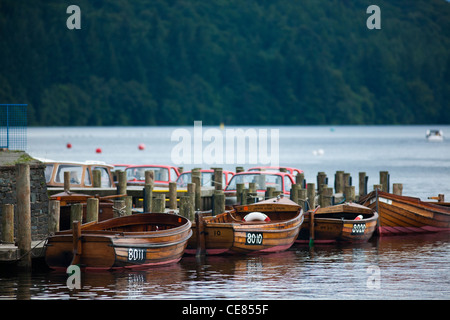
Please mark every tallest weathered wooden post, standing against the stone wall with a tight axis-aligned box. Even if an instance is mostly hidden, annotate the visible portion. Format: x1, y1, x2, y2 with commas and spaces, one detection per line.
15, 163, 31, 269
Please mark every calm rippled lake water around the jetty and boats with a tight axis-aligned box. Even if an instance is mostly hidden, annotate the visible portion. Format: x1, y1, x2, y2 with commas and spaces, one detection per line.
0, 126, 450, 300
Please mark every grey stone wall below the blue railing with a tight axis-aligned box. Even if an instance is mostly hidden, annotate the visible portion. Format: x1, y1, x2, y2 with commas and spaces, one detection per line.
0, 151, 49, 240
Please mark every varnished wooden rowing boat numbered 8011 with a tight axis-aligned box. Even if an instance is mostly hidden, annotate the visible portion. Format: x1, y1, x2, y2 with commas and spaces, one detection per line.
45, 213, 192, 270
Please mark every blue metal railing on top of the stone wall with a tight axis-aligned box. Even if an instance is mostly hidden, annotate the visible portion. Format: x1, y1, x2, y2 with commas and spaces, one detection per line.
0, 104, 27, 150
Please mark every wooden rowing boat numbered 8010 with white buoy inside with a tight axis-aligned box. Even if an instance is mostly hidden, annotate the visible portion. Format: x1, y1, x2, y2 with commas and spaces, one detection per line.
186, 197, 303, 254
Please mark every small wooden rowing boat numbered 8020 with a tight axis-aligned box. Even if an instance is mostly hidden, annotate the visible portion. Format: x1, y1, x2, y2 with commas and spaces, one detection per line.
296, 203, 378, 243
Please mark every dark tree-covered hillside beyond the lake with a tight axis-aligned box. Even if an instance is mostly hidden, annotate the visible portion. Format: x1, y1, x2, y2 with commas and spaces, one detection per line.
0, 0, 450, 126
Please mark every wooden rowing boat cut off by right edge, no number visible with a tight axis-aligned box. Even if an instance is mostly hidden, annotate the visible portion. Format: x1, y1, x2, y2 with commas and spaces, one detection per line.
359, 190, 450, 235
